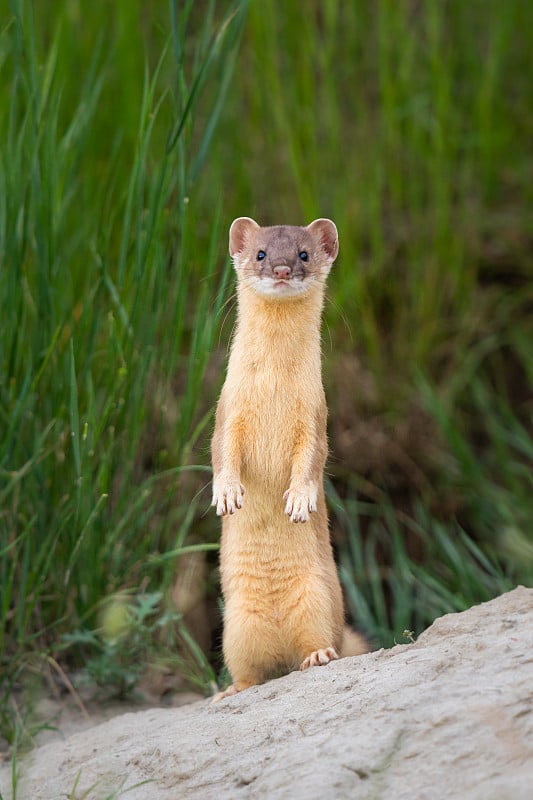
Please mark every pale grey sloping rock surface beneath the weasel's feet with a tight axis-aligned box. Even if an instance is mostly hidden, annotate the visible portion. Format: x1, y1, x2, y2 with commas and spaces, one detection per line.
0, 587, 533, 800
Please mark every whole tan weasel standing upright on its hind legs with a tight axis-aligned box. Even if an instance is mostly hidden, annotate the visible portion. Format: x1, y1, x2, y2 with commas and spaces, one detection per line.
212, 217, 368, 699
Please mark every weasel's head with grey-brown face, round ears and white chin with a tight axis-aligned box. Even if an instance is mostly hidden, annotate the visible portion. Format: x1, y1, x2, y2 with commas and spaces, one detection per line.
229, 217, 339, 300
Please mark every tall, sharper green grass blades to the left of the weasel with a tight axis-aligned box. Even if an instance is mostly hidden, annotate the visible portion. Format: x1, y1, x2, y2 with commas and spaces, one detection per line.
0, 3, 246, 752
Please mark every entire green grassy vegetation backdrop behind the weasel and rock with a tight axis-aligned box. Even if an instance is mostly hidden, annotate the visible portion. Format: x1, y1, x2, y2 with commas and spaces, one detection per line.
0, 0, 533, 742
